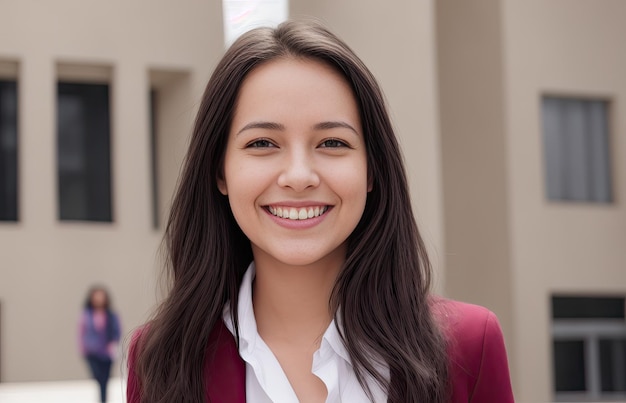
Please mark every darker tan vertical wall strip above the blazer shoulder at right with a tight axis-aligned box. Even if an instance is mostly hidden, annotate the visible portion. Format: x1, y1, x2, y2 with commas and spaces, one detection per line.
436, 0, 516, 392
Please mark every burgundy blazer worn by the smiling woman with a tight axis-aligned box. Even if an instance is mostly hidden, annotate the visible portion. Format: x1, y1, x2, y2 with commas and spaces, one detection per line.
126, 299, 514, 403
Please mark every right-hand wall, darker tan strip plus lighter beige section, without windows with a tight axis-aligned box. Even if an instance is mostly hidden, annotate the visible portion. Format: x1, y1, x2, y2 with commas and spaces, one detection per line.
436, 0, 626, 402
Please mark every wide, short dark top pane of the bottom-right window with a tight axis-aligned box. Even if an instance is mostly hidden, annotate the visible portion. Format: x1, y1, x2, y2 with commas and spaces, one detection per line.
552, 296, 625, 319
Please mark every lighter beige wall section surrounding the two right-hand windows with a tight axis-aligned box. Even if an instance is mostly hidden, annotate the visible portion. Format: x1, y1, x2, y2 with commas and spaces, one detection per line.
502, 0, 626, 402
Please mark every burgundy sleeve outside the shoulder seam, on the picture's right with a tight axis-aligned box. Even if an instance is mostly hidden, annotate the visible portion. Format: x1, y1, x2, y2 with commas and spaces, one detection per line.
470, 312, 514, 403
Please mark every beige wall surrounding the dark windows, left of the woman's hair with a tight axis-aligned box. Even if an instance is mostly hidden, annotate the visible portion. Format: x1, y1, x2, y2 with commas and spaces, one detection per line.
0, 0, 223, 381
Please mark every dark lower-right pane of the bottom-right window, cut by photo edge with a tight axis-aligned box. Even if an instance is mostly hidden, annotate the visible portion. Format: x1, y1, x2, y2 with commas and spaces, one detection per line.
600, 338, 626, 392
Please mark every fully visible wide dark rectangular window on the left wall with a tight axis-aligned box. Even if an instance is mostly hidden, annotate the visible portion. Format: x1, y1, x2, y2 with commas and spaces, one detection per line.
57, 82, 112, 222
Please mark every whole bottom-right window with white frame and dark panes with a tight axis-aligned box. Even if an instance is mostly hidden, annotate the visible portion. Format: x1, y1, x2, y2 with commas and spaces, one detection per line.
552, 296, 626, 402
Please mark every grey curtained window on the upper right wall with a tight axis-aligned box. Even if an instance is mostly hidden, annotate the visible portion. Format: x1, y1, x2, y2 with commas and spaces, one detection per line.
542, 96, 612, 203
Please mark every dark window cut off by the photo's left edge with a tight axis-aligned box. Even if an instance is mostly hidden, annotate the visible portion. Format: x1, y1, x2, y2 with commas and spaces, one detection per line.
0, 80, 18, 221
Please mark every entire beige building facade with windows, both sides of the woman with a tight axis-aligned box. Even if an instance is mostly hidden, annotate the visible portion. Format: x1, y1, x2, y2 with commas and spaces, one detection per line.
0, 0, 626, 402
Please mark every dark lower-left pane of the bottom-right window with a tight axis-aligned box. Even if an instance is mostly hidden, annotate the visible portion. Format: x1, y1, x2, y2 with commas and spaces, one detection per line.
554, 340, 587, 392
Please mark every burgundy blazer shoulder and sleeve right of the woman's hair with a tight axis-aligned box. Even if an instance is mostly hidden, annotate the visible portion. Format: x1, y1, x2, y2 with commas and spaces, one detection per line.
432, 298, 514, 403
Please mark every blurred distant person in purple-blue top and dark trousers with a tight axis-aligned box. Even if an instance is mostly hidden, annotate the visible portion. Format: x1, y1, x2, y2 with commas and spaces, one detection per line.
79, 286, 120, 402
